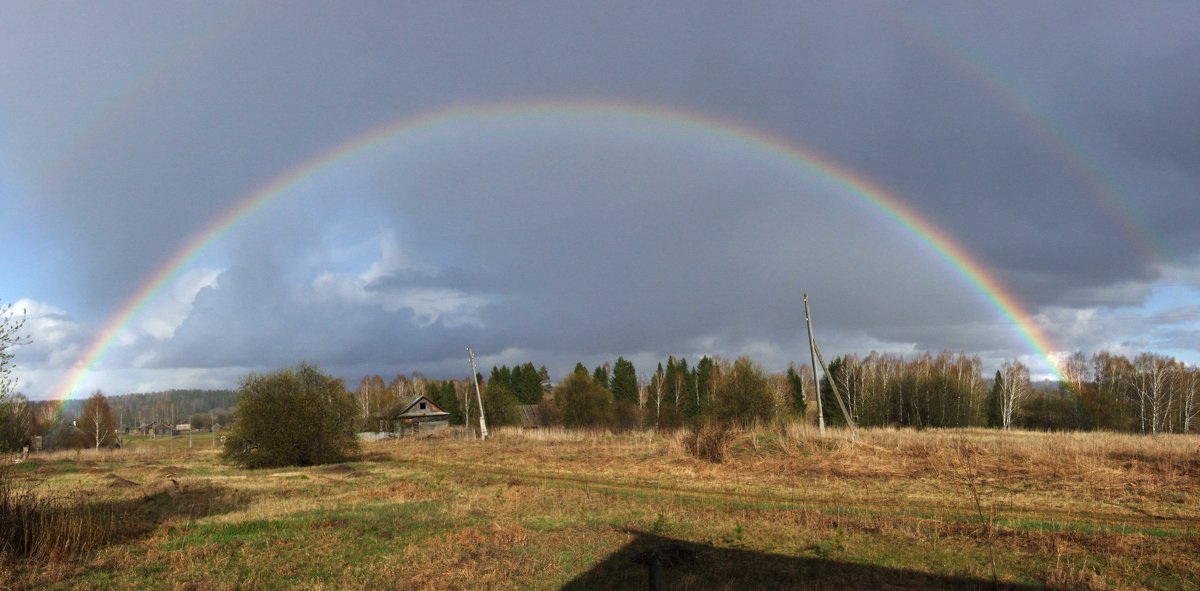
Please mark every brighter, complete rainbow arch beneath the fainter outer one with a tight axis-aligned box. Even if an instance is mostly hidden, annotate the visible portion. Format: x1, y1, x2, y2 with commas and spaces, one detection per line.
56, 101, 1058, 400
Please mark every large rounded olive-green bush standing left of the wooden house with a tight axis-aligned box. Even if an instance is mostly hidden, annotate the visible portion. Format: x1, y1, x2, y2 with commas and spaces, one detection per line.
222, 364, 359, 468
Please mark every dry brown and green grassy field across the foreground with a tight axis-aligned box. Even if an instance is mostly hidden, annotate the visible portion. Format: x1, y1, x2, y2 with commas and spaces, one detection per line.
0, 425, 1200, 590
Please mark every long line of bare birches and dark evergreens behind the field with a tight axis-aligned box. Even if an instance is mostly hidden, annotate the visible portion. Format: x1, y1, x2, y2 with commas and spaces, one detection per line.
0, 351, 1200, 450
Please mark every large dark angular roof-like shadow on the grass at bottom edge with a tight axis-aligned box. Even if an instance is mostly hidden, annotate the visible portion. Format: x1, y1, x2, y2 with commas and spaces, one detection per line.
562, 530, 1044, 591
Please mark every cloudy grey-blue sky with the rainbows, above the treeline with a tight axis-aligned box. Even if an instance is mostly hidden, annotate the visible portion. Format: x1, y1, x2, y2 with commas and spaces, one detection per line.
0, 0, 1200, 399
